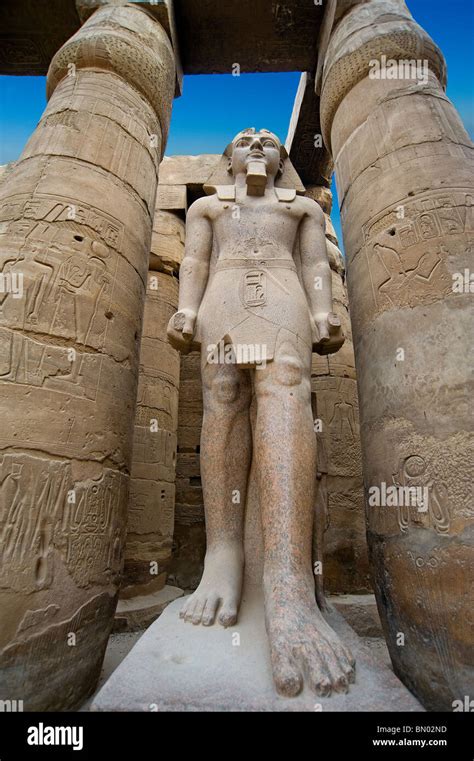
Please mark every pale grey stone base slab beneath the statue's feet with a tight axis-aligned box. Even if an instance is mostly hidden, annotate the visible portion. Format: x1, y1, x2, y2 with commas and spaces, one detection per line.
90, 584, 424, 713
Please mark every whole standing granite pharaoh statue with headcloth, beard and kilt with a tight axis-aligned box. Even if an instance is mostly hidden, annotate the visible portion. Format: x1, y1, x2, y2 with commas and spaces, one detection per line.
168, 129, 354, 697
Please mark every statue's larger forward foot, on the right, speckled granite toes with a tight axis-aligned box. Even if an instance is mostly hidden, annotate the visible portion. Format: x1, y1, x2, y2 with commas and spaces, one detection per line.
265, 581, 355, 697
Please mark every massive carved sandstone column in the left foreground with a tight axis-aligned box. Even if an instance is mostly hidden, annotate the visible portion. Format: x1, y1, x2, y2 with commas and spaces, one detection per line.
0, 6, 175, 710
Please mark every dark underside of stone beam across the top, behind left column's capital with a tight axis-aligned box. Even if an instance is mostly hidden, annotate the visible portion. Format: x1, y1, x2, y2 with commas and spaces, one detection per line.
0, 0, 324, 74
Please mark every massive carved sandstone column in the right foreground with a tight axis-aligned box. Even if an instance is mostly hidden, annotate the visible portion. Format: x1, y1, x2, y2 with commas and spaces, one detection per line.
321, 0, 474, 710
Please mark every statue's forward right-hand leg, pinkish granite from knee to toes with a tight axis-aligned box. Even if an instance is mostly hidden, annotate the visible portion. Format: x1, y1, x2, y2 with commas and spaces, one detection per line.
255, 340, 354, 696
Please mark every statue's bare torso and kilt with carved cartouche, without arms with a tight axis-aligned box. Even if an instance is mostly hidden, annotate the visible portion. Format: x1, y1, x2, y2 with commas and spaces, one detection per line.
193, 189, 311, 359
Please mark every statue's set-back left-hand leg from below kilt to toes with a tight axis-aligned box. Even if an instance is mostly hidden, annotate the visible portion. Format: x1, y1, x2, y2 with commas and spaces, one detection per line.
181, 361, 252, 626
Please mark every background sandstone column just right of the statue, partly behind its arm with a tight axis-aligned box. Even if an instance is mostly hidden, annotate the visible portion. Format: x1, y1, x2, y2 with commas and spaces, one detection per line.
306, 185, 372, 594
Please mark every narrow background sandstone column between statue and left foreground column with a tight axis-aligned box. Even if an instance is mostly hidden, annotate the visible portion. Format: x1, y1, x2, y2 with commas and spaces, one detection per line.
115, 209, 184, 629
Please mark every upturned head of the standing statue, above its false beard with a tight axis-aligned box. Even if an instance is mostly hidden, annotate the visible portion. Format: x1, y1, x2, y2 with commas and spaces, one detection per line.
226, 127, 288, 178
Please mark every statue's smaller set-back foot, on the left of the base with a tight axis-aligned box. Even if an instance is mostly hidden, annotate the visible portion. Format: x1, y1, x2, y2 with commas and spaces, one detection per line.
180, 543, 244, 626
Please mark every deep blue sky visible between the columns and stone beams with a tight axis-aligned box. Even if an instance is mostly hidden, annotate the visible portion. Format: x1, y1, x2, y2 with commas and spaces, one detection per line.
0, 0, 474, 243
